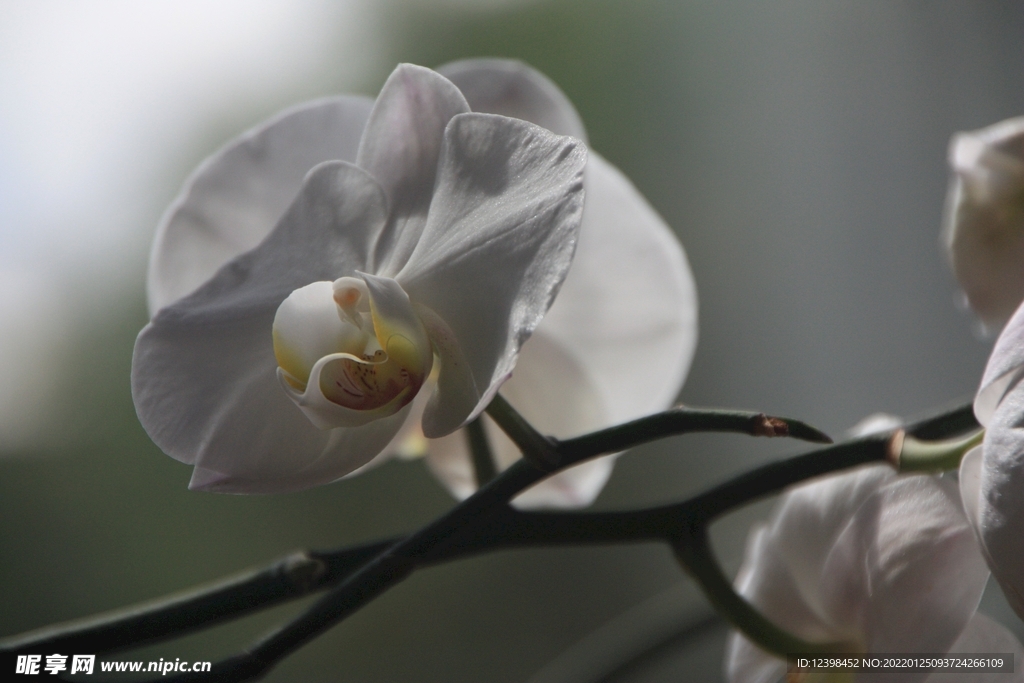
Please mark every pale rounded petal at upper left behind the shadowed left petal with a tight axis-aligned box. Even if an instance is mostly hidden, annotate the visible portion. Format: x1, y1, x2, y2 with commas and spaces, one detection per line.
146, 96, 373, 316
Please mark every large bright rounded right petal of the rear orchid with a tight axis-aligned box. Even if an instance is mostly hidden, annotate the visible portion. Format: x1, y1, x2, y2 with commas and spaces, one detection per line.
539, 152, 697, 423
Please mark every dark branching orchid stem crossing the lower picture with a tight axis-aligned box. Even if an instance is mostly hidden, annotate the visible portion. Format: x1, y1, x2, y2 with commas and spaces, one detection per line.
0, 400, 977, 682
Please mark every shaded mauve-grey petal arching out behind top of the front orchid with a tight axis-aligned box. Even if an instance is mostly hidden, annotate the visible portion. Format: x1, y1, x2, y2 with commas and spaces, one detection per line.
437, 58, 587, 142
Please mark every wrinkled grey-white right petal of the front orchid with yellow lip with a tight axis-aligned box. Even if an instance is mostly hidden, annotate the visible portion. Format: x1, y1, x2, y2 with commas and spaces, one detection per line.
395, 114, 586, 430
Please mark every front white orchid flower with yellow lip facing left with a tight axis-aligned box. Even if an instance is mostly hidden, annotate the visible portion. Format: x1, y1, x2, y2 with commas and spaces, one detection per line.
132, 65, 586, 493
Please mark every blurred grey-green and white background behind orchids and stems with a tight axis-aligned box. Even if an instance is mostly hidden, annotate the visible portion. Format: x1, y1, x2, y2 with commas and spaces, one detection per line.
0, 0, 1024, 683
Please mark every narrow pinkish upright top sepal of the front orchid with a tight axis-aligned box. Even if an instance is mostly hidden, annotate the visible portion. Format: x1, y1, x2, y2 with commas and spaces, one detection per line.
355, 65, 469, 275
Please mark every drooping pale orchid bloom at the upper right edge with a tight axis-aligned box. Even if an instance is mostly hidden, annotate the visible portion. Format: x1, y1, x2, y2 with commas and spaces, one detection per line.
943, 117, 1024, 330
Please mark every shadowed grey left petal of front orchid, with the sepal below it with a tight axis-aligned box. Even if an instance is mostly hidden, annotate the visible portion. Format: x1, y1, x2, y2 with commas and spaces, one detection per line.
132, 162, 393, 490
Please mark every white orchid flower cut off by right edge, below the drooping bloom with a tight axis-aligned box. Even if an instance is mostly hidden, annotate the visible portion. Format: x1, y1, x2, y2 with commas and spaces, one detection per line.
961, 304, 1024, 617
